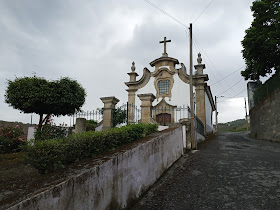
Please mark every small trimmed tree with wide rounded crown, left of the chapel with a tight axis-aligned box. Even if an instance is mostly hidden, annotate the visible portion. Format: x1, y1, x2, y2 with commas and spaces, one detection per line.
5, 76, 86, 130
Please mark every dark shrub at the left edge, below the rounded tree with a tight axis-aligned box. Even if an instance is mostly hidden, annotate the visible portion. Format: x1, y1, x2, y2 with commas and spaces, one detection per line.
0, 126, 26, 154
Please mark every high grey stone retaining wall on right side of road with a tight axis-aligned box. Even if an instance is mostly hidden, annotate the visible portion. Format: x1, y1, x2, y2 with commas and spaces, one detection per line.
250, 88, 280, 141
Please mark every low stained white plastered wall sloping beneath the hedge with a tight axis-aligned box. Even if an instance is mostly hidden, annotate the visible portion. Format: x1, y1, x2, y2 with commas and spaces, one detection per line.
7, 127, 183, 210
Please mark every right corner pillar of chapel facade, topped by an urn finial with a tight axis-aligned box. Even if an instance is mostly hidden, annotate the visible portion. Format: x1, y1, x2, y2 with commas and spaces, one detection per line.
194, 53, 207, 134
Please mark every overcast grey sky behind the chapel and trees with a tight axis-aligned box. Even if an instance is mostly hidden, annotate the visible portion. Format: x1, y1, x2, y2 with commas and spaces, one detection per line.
0, 0, 253, 123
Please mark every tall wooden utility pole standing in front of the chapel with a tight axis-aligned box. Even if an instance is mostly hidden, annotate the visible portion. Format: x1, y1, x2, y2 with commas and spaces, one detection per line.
190, 24, 197, 149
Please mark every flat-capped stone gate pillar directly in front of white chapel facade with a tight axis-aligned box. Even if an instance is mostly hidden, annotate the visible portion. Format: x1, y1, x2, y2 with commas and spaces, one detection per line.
137, 93, 156, 123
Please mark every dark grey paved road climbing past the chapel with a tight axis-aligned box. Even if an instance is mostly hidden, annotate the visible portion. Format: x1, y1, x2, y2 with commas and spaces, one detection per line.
132, 133, 280, 210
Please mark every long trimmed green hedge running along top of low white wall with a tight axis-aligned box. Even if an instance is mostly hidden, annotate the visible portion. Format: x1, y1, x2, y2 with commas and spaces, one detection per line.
24, 124, 157, 174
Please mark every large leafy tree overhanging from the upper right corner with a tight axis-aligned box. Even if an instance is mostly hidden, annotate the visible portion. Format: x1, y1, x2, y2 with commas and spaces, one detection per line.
241, 0, 280, 80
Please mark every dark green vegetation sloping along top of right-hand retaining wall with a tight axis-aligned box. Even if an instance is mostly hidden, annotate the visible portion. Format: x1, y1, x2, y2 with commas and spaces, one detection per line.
254, 73, 280, 104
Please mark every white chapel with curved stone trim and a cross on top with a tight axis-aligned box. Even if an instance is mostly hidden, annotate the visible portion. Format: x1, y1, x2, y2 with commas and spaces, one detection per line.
125, 37, 215, 134
